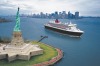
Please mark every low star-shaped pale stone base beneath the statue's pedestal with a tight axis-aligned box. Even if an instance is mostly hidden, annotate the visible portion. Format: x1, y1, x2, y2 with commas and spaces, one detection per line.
0, 43, 43, 62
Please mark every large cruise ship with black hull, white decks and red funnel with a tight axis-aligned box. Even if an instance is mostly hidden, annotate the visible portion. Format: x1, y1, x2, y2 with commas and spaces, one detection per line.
44, 19, 84, 37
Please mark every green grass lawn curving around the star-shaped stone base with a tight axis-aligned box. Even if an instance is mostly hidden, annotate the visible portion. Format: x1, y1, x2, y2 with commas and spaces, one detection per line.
0, 41, 57, 66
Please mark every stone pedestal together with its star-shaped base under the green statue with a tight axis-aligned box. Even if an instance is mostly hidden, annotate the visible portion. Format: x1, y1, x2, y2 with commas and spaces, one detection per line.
0, 31, 43, 62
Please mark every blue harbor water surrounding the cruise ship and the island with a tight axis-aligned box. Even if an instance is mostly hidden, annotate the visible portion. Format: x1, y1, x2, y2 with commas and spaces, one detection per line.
0, 17, 100, 66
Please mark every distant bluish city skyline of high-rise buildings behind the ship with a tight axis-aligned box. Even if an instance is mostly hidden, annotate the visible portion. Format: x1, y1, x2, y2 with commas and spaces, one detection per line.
27, 11, 81, 19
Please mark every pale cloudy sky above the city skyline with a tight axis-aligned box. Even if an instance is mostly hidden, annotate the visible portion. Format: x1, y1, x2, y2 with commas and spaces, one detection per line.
0, 0, 100, 16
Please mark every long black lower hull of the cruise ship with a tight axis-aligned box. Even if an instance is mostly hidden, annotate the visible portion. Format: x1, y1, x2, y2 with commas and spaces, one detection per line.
45, 25, 83, 37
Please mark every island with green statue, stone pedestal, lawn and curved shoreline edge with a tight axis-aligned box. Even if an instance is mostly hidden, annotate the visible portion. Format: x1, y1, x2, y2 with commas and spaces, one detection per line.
0, 8, 63, 66
